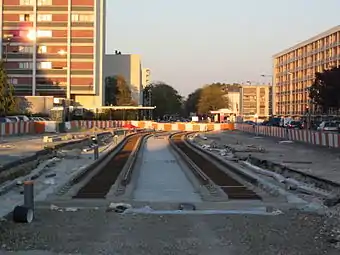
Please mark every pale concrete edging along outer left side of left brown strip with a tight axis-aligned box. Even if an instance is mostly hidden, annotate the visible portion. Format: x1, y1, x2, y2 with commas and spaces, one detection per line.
56, 134, 139, 198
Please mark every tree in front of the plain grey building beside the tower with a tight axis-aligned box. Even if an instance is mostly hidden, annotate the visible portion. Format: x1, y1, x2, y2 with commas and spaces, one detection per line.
105, 75, 135, 106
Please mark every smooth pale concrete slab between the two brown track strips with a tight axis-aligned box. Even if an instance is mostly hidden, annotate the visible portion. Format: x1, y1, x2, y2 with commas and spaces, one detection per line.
134, 137, 201, 202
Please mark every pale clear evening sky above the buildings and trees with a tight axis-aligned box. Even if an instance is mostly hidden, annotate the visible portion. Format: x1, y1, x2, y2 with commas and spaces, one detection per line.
106, 0, 340, 96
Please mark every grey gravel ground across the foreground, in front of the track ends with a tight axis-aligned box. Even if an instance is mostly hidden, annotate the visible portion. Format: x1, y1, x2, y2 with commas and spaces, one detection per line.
0, 209, 339, 255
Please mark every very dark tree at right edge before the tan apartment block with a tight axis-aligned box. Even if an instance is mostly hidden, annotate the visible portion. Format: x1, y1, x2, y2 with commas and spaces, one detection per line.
309, 67, 340, 113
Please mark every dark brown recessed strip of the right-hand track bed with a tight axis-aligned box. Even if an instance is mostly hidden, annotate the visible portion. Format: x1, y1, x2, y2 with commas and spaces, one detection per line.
171, 133, 261, 200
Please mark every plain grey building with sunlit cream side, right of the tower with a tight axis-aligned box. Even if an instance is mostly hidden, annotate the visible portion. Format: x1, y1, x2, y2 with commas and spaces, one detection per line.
105, 54, 143, 105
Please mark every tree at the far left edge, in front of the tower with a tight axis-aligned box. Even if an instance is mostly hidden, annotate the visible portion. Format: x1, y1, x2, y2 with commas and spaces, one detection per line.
0, 61, 16, 116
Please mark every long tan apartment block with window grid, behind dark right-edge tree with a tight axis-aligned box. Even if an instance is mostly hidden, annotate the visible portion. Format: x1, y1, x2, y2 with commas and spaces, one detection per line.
273, 26, 340, 117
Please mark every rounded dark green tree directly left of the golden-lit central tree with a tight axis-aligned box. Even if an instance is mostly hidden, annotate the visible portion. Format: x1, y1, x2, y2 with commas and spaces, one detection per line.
144, 82, 182, 118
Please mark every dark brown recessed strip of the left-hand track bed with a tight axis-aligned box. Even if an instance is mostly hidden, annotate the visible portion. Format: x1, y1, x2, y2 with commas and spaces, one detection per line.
73, 134, 145, 198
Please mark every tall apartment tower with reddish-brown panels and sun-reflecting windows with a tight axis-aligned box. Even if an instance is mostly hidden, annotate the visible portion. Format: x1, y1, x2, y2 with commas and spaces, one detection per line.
0, 0, 106, 108
